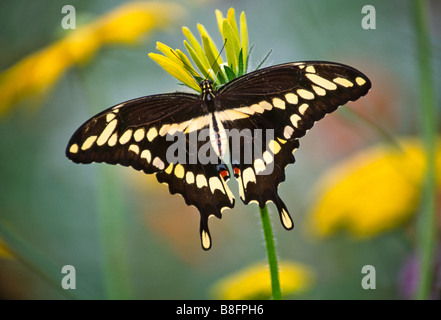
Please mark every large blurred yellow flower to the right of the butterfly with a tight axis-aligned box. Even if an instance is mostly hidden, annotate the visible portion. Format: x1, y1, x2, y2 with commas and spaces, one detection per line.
309, 138, 441, 238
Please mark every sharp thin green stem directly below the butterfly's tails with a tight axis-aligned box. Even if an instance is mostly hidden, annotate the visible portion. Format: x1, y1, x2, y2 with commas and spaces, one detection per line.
259, 206, 282, 300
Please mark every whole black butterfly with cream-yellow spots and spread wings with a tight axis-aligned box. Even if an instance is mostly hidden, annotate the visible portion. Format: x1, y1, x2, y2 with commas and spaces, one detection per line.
66, 61, 371, 250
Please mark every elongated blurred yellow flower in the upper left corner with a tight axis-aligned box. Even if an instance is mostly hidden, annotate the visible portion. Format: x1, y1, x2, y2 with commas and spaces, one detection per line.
0, 2, 184, 116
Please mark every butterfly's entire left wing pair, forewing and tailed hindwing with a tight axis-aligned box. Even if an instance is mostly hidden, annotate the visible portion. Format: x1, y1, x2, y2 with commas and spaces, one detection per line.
66, 93, 234, 249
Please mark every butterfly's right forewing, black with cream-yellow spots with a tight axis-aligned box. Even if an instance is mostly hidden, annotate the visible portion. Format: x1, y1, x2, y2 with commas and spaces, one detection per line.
218, 61, 371, 139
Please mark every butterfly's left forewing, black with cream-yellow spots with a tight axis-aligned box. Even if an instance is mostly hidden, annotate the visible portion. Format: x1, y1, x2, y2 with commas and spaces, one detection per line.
66, 93, 199, 173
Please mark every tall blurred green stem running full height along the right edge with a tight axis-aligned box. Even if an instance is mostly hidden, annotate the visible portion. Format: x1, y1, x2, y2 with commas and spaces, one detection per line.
412, 0, 437, 299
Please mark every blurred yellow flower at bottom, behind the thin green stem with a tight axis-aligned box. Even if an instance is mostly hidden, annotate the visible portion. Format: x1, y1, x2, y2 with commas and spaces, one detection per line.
212, 261, 314, 300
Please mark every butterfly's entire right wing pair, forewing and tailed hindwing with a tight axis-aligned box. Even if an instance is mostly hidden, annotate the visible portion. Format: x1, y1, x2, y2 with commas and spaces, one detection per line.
218, 61, 371, 229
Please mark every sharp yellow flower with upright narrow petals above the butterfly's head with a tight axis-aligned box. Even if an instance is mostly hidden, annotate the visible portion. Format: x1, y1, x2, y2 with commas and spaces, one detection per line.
149, 8, 249, 92
